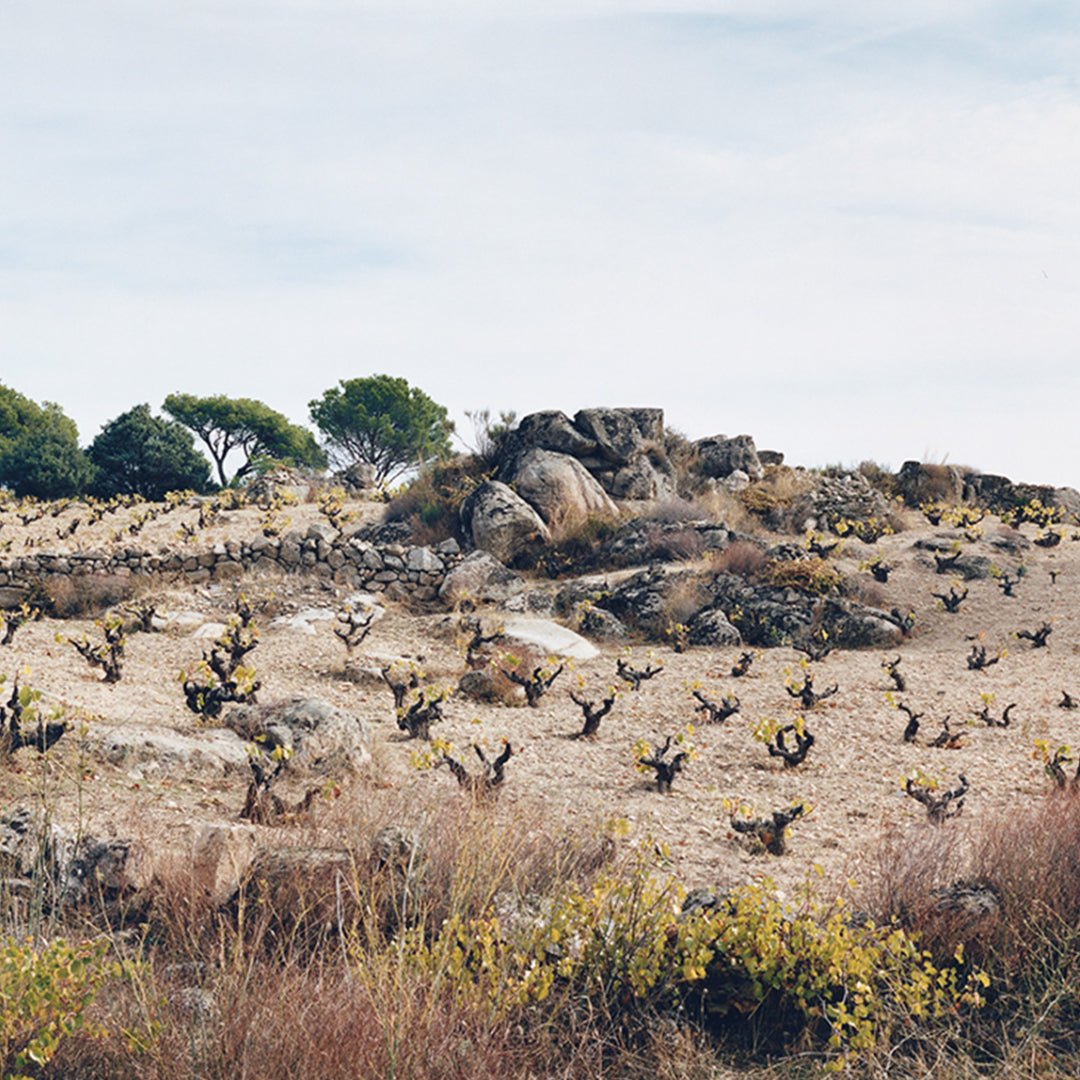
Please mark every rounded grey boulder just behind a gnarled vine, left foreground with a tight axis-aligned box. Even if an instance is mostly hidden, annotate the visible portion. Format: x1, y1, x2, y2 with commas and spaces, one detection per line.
226, 698, 372, 777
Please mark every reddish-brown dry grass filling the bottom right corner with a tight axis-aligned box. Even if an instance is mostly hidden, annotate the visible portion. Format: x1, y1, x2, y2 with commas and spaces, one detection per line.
861, 792, 1080, 1077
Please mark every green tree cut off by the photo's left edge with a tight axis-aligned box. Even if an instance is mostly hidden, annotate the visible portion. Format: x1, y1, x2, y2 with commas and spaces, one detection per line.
0, 384, 93, 499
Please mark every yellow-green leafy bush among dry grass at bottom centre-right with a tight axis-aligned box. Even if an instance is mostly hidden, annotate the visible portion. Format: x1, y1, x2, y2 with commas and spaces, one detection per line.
388, 860, 988, 1070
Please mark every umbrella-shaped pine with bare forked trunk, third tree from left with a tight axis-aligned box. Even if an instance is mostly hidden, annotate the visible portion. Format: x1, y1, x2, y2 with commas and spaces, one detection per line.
163, 394, 326, 487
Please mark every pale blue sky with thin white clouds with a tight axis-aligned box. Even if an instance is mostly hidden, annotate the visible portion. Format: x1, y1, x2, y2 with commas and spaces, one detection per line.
0, 0, 1080, 487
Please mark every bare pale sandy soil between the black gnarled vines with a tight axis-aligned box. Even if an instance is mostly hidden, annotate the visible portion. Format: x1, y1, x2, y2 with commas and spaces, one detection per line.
0, 496, 1080, 890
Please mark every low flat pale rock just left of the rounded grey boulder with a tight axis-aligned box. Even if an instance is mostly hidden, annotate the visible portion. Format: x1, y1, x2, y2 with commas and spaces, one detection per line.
86, 724, 248, 777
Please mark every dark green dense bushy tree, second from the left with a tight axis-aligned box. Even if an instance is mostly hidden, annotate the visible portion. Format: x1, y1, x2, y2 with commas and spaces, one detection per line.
86, 405, 210, 501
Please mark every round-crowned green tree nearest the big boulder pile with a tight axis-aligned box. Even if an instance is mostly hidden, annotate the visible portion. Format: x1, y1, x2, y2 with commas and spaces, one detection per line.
309, 375, 454, 484
